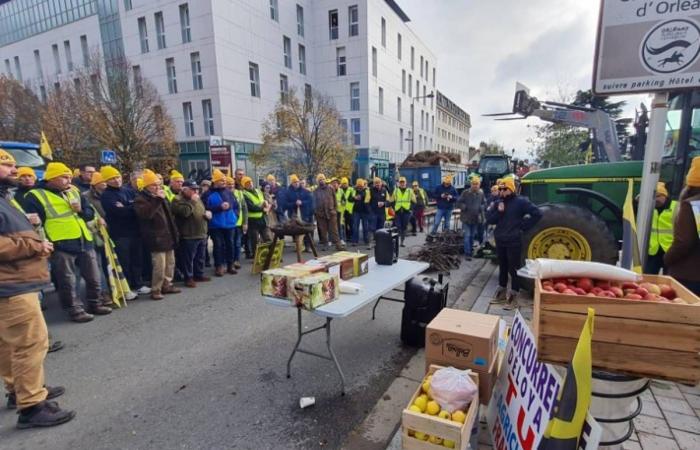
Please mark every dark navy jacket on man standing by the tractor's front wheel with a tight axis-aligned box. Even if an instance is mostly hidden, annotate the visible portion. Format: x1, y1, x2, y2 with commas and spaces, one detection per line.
486, 195, 542, 246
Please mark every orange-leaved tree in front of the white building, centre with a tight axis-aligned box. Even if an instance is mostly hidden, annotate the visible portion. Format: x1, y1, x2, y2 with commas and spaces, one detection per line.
258, 89, 355, 177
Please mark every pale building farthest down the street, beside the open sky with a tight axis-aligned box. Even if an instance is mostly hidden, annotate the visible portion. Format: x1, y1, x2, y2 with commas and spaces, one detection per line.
435, 91, 472, 164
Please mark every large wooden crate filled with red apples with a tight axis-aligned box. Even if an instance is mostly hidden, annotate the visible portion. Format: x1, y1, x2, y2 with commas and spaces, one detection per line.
533, 275, 700, 384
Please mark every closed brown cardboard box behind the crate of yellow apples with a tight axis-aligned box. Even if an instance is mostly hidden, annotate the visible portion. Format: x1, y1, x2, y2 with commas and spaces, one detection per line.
425, 308, 500, 373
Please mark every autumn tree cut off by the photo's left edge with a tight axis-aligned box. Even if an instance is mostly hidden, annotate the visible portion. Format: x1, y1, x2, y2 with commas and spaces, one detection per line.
0, 75, 41, 142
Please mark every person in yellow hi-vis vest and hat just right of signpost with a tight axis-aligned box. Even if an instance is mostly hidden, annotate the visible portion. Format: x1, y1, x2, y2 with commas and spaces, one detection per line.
644, 182, 678, 275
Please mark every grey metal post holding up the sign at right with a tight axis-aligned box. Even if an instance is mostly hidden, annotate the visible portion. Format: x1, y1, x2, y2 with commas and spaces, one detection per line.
637, 92, 668, 267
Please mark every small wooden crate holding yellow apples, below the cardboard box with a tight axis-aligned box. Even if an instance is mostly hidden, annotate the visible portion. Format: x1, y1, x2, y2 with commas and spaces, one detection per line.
401, 364, 479, 450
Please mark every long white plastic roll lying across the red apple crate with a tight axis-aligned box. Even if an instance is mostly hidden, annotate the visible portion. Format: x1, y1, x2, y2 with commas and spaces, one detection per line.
518, 258, 642, 282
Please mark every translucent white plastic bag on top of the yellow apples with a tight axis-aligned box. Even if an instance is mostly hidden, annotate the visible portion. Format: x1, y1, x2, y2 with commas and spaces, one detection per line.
430, 367, 479, 414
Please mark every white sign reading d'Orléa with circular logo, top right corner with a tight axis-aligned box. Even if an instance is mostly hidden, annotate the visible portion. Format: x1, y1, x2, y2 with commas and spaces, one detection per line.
593, 0, 700, 95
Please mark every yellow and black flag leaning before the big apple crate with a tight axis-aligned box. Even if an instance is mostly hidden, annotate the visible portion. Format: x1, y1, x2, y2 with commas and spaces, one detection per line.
538, 308, 595, 450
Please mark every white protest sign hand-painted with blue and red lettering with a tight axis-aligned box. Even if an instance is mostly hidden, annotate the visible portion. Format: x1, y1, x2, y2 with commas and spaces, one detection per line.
486, 312, 601, 450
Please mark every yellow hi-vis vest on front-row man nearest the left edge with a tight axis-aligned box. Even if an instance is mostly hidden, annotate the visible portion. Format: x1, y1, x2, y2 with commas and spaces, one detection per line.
29, 187, 92, 242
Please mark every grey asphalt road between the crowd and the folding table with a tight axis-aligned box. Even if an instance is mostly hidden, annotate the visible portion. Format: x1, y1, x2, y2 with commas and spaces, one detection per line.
0, 237, 480, 450
